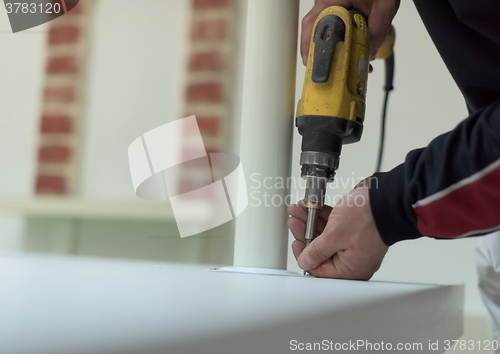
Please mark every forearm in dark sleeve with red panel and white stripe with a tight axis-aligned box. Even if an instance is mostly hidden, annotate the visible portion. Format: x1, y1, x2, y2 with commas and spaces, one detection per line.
370, 101, 500, 245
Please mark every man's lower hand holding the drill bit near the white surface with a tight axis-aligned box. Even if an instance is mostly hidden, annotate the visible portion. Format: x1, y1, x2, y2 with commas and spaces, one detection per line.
288, 180, 389, 280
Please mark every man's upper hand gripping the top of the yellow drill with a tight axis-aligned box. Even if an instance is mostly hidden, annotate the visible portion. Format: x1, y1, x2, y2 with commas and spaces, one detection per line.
300, 0, 400, 65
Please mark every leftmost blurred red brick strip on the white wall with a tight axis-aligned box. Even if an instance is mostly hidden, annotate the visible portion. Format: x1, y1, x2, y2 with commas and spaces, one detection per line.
35, 0, 94, 195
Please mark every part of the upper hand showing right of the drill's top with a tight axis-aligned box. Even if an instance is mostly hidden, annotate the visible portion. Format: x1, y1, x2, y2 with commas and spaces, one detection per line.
368, 0, 399, 58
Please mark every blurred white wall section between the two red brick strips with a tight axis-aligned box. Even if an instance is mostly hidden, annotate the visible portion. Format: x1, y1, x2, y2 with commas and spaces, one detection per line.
82, 0, 191, 199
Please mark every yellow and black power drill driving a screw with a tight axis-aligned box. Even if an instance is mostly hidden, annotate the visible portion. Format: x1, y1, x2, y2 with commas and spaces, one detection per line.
296, 6, 395, 249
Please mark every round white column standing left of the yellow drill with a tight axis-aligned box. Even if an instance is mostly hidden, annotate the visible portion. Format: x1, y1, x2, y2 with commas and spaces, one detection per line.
234, 0, 299, 269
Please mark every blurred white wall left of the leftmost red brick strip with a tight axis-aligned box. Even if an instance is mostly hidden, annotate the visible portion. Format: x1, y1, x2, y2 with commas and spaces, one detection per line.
0, 11, 47, 250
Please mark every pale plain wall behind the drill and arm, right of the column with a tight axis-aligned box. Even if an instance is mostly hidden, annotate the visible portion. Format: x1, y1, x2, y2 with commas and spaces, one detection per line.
289, 0, 486, 314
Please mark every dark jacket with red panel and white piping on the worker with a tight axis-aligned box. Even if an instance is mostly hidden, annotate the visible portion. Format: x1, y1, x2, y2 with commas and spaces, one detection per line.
370, 0, 500, 245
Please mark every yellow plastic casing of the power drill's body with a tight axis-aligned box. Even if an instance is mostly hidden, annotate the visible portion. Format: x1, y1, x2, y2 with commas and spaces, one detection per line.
297, 6, 370, 133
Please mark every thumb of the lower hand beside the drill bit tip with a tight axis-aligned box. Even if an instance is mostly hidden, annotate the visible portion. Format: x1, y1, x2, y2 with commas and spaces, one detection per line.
298, 224, 341, 270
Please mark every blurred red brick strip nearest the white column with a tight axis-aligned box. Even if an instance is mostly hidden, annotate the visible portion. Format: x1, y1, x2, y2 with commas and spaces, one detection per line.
180, 0, 235, 189
